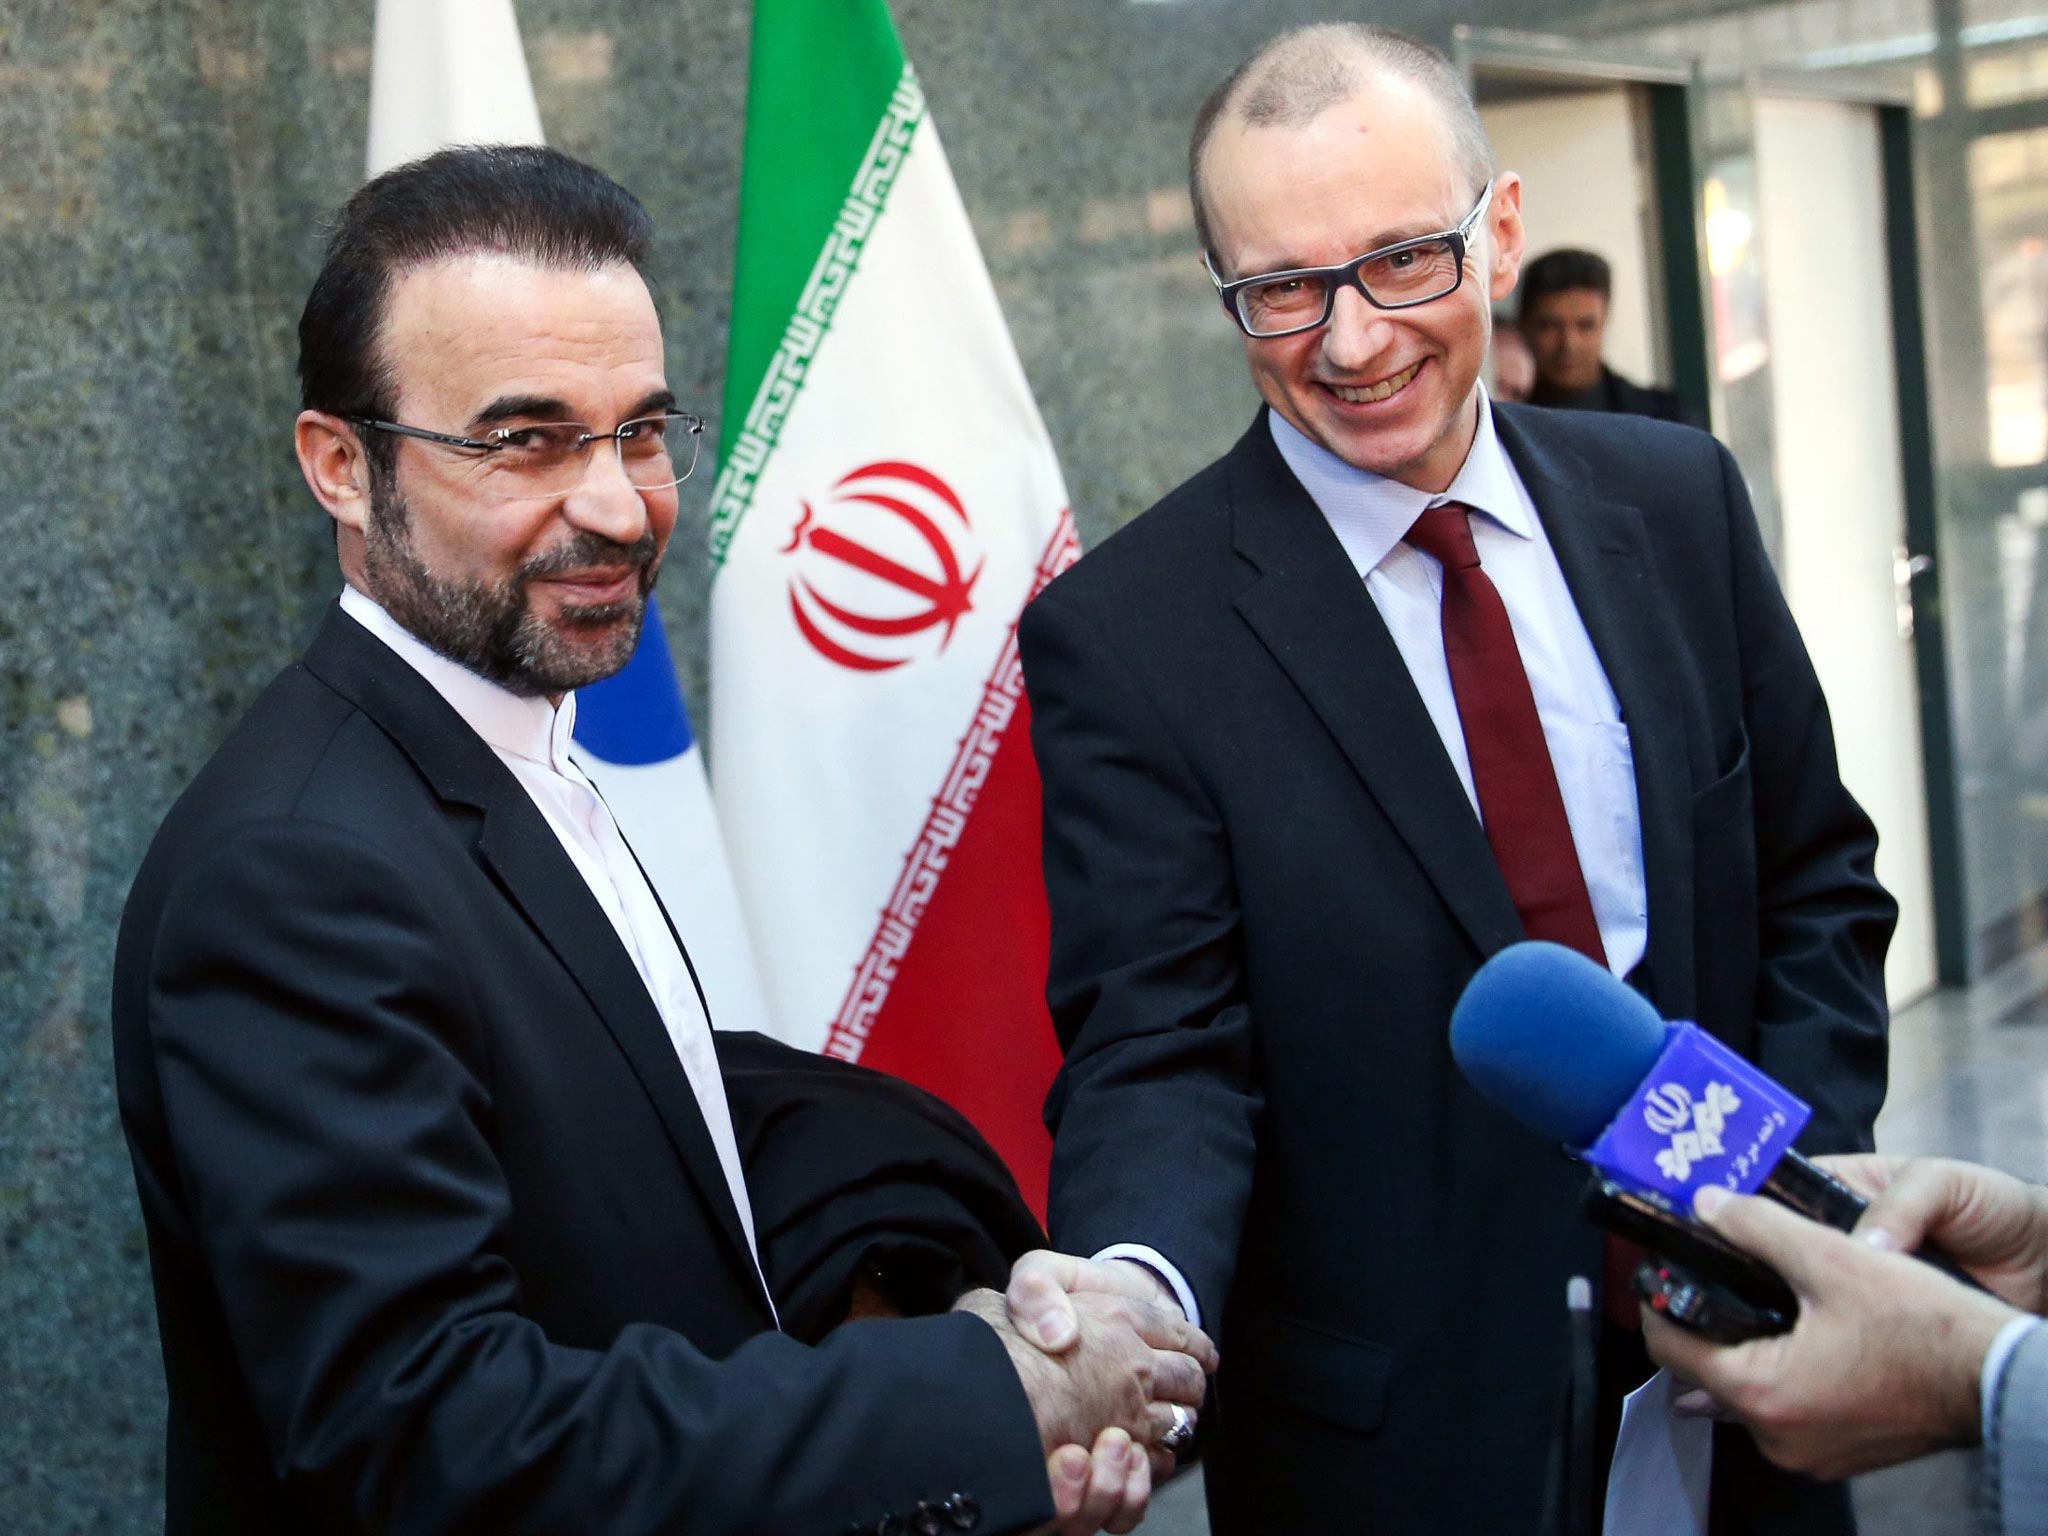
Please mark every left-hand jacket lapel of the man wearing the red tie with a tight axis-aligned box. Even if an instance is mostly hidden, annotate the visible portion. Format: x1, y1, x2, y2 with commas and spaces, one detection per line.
1229, 414, 1522, 954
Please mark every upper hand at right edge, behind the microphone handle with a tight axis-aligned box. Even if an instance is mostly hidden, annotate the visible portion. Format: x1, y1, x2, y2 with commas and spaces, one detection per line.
1815, 1155, 2048, 1315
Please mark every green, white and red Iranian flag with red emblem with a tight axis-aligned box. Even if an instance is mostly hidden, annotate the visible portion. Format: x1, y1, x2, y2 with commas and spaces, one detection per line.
711, 0, 1079, 1210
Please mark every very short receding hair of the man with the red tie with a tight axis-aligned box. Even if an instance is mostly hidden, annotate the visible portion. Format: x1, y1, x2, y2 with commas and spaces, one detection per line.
1188, 20, 1495, 268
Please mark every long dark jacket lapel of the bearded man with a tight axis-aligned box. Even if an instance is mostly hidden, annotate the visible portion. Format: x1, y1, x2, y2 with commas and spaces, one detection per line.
305, 608, 758, 1302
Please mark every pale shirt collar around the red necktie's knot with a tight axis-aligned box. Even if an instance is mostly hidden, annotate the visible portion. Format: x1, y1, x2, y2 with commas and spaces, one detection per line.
1266, 385, 1536, 573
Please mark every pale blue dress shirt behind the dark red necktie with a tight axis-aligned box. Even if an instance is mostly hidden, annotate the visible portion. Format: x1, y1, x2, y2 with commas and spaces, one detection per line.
1266, 391, 1649, 975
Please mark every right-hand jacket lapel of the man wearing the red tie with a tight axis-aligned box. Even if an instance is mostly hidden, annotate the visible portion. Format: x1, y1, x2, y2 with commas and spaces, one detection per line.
1493, 406, 1694, 1012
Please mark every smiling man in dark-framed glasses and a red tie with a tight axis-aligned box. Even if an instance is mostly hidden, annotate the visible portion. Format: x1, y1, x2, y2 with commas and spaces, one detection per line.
1022, 27, 1894, 1536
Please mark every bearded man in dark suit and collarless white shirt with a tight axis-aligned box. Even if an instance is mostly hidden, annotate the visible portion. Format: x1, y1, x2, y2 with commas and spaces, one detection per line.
115, 150, 1214, 1532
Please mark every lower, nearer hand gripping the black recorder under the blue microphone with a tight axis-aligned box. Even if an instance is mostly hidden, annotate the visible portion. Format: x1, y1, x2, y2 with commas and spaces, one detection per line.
1642, 1190, 2013, 1479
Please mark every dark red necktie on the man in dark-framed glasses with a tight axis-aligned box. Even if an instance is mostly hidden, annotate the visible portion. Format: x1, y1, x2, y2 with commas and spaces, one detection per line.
1407, 502, 1642, 1329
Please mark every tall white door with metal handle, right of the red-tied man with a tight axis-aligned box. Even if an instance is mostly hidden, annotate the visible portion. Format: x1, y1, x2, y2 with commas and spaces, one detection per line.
1753, 90, 1939, 1008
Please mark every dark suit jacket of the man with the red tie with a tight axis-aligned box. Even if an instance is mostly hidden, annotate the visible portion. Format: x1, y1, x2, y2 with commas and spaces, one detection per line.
1022, 408, 1894, 1536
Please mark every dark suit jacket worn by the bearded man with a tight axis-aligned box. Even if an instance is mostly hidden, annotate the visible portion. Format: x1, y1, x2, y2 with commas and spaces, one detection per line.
113, 610, 1051, 1536
